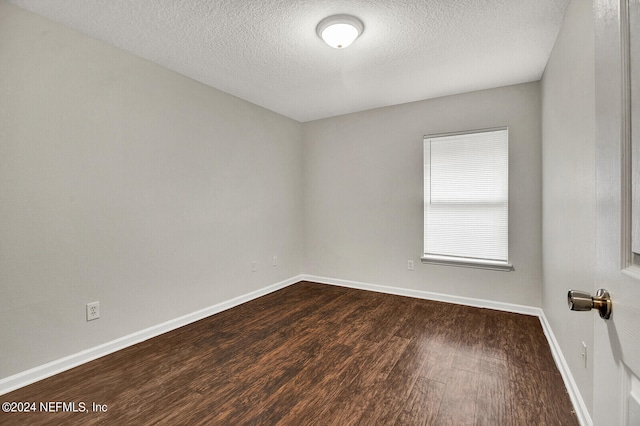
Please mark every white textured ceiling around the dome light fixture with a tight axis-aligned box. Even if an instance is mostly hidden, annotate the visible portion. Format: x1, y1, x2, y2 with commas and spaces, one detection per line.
9, 0, 569, 122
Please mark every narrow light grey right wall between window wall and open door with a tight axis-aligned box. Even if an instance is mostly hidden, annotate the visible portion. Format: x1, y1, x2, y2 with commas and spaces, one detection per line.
542, 0, 599, 411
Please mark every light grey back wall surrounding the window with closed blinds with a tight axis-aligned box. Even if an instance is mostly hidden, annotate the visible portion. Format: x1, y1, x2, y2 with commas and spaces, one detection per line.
303, 82, 542, 306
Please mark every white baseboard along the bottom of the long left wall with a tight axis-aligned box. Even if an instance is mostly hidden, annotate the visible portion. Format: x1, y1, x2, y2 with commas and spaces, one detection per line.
0, 276, 303, 395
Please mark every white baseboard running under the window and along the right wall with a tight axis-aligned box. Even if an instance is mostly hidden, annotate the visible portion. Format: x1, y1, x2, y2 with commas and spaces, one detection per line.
301, 274, 593, 426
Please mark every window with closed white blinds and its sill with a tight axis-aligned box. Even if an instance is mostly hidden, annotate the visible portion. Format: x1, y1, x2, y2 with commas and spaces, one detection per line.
422, 128, 513, 271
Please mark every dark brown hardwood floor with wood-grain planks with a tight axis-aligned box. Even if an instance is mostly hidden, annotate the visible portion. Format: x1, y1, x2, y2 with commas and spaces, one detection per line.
0, 282, 578, 425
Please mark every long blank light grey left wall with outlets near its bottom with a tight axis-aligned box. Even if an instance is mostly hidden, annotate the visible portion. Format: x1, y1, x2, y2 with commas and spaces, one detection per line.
0, 3, 302, 379
